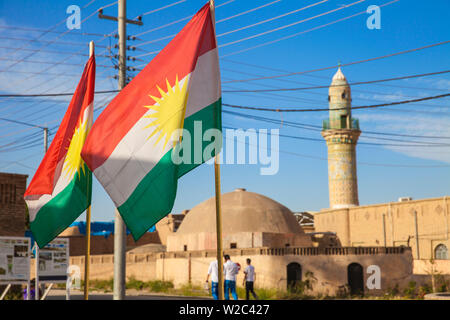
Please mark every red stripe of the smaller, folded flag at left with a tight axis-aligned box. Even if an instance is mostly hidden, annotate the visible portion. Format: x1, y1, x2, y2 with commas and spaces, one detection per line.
24, 56, 95, 198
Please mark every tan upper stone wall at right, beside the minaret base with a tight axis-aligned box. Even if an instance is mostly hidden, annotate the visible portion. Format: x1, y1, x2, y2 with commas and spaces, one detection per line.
314, 197, 450, 260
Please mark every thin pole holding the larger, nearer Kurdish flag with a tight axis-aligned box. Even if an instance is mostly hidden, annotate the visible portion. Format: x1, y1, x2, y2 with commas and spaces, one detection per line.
209, 0, 224, 300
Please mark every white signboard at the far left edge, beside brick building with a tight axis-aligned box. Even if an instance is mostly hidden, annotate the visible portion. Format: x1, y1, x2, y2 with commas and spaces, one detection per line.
0, 237, 30, 284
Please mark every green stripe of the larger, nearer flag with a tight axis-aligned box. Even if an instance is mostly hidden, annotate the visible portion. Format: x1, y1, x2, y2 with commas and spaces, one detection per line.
118, 99, 222, 241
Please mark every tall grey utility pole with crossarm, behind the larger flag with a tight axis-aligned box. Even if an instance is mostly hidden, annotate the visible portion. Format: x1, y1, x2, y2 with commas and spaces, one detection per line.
98, 0, 143, 300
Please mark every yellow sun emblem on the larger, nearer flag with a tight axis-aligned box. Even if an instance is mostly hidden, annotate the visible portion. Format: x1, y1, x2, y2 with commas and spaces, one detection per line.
145, 75, 188, 148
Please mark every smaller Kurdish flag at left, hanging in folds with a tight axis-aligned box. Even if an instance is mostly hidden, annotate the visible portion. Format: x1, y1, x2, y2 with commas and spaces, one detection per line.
24, 55, 95, 248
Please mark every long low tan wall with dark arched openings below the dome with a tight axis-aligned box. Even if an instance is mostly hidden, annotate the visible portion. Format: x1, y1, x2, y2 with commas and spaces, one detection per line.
70, 247, 413, 294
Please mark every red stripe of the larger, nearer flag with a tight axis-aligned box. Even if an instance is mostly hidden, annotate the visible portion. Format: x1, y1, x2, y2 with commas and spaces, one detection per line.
81, 3, 216, 171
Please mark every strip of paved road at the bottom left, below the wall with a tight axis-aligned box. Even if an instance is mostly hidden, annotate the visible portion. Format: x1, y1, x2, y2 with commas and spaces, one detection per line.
46, 289, 210, 300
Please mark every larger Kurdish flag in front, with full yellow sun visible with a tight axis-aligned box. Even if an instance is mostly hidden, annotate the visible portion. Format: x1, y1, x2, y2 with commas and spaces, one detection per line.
82, 4, 222, 240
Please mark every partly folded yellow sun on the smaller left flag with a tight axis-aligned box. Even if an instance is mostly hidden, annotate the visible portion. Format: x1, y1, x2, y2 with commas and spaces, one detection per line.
63, 121, 88, 178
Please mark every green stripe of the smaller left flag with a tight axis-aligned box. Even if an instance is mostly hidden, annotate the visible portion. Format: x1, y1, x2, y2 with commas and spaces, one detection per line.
30, 164, 92, 248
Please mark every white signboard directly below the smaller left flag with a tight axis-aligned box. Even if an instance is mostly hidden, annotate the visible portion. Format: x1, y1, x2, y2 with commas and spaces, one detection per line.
39, 239, 69, 283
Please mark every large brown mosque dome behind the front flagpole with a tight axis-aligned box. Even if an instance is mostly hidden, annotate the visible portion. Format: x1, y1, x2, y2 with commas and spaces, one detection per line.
177, 189, 304, 235
